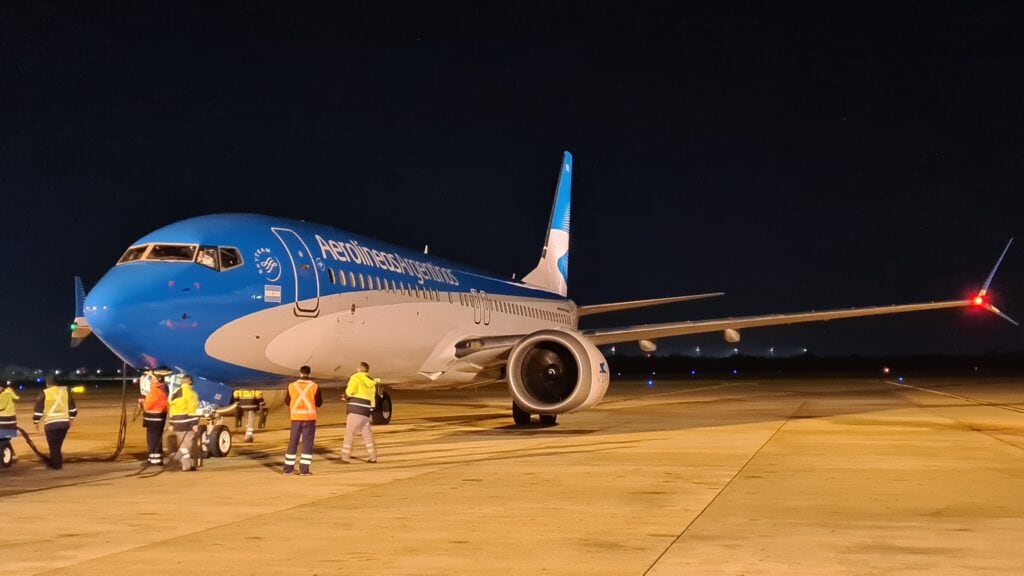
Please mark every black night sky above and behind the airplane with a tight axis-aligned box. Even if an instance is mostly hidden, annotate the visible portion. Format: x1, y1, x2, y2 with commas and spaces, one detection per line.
0, 1, 1024, 368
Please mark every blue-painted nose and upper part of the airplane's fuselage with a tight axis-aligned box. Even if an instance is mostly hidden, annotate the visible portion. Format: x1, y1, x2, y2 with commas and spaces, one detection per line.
84, 214, 563, 381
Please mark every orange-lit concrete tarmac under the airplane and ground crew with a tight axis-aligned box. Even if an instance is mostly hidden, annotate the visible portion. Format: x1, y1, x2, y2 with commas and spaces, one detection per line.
0, 377, 1024, 576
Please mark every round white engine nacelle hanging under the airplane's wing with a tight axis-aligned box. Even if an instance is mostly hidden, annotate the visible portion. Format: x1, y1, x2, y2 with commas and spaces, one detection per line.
508, 330, 608, 414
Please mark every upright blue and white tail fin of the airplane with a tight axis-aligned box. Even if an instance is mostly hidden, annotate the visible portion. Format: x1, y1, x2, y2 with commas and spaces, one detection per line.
522, 151, 572, 296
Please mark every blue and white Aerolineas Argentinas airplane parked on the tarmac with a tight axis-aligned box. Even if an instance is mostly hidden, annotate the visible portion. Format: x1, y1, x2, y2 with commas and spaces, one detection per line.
72, 152, 1012, 423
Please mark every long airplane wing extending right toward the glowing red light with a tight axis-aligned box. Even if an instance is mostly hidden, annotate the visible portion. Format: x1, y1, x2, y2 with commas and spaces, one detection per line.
581, 298, 974, 345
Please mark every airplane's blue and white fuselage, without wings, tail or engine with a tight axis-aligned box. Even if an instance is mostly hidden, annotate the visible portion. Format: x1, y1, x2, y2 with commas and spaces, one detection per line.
84, 214, 578, 387
